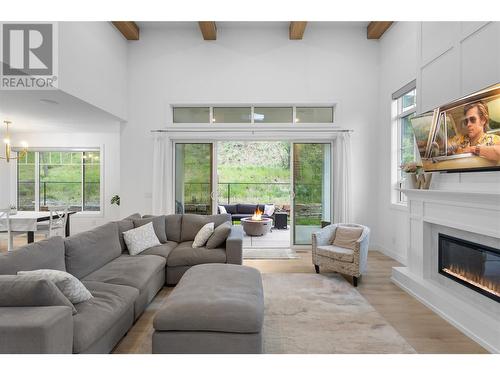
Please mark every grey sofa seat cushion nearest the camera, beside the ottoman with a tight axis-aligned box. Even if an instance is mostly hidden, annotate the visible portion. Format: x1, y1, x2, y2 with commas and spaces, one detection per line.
73, 281, 139, 353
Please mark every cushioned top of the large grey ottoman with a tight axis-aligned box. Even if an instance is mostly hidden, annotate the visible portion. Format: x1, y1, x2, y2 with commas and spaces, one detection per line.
153, 264, 264, 333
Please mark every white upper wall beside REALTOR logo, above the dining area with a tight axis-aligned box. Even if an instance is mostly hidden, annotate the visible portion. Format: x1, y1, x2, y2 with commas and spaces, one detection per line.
58, 22, 127, 119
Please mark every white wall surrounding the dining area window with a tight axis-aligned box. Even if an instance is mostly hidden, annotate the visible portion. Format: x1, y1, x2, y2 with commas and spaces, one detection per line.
6, 129, 120, 234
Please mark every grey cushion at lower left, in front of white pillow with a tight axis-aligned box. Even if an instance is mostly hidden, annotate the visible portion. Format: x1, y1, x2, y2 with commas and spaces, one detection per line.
0, 275, 76, 315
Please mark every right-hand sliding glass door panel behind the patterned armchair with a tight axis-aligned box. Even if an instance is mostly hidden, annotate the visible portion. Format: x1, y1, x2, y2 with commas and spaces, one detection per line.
292, 143, 332, 245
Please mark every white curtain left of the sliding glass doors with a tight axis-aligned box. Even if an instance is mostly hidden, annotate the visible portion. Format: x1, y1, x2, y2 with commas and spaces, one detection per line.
152, 132, 168, 215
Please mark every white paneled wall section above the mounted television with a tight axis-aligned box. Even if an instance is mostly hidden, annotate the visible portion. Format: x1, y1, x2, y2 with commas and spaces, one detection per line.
417, 22, 500, 112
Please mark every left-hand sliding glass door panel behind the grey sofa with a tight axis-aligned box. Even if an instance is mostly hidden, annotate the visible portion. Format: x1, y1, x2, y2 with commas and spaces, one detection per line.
175, 143, 215, 215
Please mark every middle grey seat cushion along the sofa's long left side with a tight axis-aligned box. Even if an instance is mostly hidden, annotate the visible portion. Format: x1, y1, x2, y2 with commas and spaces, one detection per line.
84, 255, 166, 292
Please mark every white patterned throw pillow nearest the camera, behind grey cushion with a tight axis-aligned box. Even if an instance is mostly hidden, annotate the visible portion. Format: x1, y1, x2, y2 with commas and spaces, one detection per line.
17, 269, 92, 304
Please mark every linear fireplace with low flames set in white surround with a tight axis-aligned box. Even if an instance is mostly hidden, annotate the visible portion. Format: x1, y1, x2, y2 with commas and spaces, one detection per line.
438, 233, 500, 302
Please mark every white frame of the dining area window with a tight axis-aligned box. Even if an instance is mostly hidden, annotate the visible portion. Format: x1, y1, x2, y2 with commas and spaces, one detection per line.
11, 146, 105, 217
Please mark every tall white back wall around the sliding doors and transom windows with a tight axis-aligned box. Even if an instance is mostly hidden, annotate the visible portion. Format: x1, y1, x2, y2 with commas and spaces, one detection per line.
121, 23, 379, 229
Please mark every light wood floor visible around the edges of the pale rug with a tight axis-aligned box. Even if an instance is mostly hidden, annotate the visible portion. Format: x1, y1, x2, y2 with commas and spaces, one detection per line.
0, 237, 486, 353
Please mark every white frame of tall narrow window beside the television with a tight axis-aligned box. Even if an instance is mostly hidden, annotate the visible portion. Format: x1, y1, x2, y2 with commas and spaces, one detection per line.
391, 81, 418, 209
